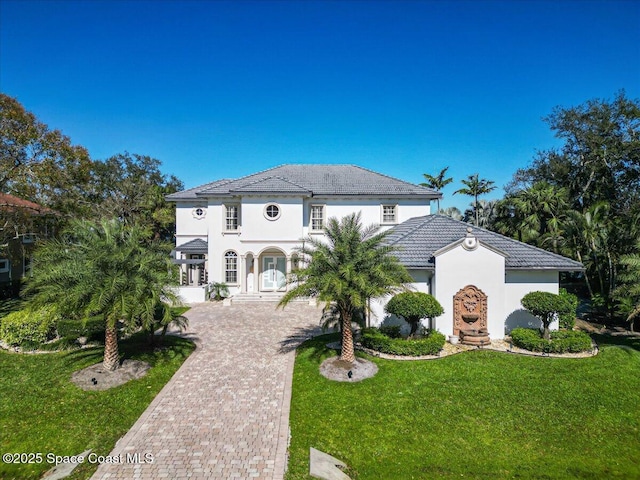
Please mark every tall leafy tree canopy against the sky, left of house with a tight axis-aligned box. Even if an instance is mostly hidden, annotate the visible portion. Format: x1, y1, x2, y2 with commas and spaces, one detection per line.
0, 94, 183, 238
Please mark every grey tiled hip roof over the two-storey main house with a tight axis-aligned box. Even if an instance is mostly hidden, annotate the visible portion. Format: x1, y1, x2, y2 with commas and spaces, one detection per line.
167, 164, 442, 200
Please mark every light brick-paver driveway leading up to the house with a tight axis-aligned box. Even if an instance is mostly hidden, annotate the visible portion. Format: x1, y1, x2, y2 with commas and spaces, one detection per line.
92, 303, 322, 480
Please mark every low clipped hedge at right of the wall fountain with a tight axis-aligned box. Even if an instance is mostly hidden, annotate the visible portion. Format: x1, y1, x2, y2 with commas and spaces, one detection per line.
511, 328, 591, 353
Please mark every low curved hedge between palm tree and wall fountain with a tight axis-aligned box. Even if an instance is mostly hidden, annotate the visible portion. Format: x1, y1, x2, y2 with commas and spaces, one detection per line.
361, 328, 445, 357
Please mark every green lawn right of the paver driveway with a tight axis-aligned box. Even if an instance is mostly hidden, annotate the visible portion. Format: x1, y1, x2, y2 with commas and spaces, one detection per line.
286, 336, 640, 480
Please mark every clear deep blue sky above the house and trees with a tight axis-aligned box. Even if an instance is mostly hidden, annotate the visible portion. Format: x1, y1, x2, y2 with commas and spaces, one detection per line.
0, 0, 640, 208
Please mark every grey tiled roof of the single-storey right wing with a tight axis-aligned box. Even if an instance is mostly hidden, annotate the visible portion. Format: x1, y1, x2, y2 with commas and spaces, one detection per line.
386, 215, 584, 271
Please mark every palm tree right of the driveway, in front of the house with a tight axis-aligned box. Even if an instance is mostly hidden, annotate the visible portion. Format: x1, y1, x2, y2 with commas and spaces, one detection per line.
278, 213, 412, 363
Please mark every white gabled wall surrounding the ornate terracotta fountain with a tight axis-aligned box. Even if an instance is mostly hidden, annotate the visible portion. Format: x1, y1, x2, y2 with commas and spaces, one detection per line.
435, 243, 506, 340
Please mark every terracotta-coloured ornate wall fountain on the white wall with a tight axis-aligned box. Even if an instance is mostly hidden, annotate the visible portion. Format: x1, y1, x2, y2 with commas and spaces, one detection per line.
453, 285, 491, 346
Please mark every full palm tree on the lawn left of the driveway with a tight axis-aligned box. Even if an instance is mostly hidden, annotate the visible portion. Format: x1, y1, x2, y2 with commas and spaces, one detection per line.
26, 220, 177, 370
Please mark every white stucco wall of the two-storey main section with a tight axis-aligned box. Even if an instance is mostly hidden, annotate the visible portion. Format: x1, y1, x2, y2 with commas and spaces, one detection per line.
176, 195, 430, 300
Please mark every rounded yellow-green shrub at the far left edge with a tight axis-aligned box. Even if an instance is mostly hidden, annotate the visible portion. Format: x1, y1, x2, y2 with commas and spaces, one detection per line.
0, 307, 58, 349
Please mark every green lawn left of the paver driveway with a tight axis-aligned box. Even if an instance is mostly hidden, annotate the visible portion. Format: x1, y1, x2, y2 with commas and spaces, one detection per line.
0, 335, 194, 480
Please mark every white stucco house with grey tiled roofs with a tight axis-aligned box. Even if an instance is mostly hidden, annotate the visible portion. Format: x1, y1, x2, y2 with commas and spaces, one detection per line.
167, 165, 582, 339
